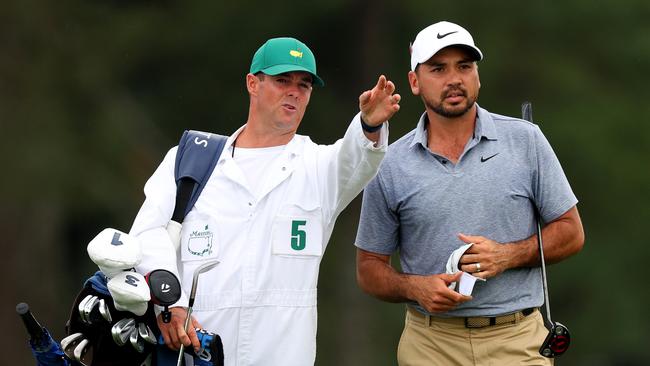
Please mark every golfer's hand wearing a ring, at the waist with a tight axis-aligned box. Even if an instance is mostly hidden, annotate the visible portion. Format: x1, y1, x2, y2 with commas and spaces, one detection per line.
458, 234, 511, 279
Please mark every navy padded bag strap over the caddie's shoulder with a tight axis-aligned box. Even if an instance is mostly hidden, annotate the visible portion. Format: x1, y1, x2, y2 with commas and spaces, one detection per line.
172, 130, 228, 223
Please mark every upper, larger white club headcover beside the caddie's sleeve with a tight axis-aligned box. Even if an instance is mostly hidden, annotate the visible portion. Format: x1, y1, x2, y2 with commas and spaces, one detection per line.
87, 228, 142, 278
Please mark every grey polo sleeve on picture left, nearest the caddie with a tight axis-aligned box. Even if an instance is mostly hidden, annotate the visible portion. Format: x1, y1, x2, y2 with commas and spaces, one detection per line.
355, 173, 399, 255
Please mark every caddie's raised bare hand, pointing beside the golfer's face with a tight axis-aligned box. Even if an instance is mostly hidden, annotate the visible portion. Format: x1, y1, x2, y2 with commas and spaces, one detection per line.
359, 75, 401, 127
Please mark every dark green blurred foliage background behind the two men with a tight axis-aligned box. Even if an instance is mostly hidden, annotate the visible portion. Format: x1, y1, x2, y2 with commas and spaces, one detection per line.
0, 0, 650, 366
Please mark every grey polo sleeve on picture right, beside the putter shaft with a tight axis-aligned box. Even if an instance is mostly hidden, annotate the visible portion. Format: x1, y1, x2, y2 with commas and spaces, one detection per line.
532, 126, 578, 222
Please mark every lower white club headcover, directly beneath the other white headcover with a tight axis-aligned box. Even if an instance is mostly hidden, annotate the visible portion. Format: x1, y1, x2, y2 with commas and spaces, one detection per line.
108, 271, 151, 316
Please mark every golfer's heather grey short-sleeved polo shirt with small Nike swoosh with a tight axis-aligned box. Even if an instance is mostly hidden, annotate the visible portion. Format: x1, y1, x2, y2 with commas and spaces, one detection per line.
355, 107, 578, 316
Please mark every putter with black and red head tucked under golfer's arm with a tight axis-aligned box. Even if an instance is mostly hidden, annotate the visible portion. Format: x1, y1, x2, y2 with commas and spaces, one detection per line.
521, 102, 571, 358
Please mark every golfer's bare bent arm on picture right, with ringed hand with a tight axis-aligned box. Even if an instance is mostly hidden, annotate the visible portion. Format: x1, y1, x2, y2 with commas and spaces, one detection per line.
459, 206, 584, 278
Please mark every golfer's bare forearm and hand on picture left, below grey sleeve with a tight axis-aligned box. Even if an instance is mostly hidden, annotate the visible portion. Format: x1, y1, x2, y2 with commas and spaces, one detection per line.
357, 249, 471, 313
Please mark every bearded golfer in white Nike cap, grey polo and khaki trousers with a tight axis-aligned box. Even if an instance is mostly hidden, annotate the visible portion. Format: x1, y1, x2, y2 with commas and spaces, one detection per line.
356, 22, 584, 366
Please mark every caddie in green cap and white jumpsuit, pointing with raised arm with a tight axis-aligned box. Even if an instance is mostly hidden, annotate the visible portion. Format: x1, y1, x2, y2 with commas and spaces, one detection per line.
130, 38, 400, 366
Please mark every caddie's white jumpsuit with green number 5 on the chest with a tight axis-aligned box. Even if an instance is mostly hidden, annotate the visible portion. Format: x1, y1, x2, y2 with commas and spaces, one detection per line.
131, 115, 388, 366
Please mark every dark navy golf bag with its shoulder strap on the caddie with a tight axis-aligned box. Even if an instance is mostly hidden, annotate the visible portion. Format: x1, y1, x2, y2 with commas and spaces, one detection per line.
17, 130, 227, 366
